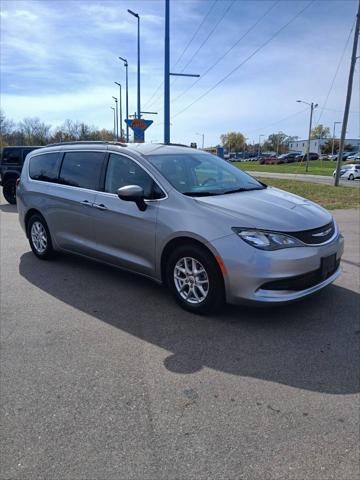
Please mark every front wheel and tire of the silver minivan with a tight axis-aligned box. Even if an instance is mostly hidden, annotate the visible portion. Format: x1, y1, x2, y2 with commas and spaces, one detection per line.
166, 245, 225, 314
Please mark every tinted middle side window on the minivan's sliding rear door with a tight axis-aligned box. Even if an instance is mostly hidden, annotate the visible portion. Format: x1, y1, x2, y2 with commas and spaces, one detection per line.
59, 152, 104, 190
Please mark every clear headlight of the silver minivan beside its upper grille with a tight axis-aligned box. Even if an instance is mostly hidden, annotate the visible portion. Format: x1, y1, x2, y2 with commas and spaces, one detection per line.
233, 227, 304, 250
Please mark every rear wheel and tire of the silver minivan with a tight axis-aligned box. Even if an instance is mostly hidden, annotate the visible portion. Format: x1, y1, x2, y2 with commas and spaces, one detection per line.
27, 214, 54, 260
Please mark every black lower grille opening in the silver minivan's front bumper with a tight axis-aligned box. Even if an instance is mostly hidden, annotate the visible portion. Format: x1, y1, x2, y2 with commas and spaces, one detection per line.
260, 259, 340, 291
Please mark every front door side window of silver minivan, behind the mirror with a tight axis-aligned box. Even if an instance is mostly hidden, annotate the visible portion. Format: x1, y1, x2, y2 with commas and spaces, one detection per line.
105, 154, 164, 199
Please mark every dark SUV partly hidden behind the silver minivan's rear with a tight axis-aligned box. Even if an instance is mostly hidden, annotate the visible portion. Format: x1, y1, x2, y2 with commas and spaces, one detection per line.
0, 146, 41, 203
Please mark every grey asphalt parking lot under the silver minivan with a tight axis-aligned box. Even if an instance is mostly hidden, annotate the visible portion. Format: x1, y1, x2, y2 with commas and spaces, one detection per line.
0, 200, 360, 480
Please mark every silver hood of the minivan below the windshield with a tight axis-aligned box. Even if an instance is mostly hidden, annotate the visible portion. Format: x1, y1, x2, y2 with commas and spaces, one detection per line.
196, 187, 332, 232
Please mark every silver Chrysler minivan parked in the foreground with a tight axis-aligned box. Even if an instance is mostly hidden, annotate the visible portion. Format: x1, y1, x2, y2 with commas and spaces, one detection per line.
17, 142, 343, 313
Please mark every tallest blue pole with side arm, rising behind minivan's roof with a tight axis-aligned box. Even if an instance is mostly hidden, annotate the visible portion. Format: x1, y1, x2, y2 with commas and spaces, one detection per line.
164, 0, 200, 144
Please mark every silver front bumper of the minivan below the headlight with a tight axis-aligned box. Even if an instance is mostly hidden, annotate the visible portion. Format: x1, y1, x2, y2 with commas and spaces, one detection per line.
212, 227, 344, 304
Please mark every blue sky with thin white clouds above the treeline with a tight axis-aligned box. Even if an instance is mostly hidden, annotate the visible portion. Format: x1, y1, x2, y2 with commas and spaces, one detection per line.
1, 0, 360, 145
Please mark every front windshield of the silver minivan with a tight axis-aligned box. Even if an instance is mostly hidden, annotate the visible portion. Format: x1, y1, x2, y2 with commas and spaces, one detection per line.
146, 151, 266, 196
